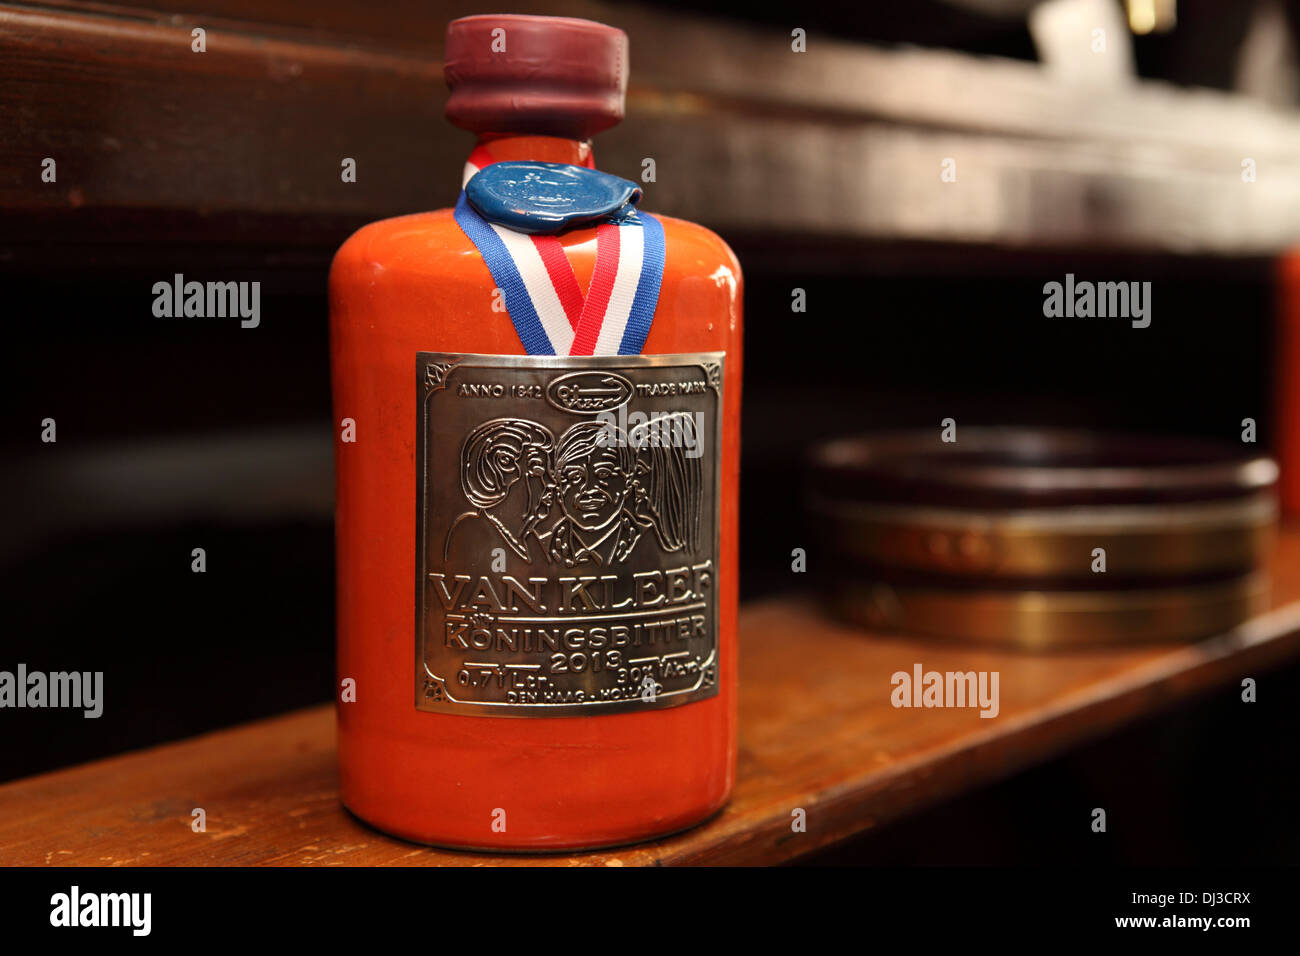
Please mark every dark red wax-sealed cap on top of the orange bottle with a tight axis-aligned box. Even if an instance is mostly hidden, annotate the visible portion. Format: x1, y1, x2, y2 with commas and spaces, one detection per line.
443, 14, 628, 139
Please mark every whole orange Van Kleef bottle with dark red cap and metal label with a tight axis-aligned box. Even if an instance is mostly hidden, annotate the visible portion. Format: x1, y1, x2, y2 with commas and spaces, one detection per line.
330, 17, 741, 851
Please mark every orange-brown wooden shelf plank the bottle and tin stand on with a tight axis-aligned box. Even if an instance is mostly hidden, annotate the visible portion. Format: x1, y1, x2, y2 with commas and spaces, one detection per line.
0, 527, 1300, 866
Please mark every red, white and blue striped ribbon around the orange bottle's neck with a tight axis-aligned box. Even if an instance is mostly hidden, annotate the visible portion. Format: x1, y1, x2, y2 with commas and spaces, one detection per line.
455, 146, 664, 355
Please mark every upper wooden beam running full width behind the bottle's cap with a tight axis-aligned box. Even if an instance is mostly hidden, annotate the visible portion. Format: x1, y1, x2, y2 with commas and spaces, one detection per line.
0, 0, 1300, 256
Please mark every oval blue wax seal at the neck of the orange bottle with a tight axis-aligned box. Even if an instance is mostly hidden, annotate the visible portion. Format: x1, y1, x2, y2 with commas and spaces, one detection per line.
465, 163, 641, 235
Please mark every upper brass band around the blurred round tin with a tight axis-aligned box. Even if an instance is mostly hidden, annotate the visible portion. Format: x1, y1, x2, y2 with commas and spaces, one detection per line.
809, 493, 1278, 580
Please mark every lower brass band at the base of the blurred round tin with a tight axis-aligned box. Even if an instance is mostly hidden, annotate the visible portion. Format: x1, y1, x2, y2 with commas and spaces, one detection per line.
836, 574, 1269, 650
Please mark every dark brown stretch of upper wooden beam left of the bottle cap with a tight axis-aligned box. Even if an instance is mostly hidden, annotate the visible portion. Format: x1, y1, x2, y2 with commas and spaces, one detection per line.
0, 8, 444, 245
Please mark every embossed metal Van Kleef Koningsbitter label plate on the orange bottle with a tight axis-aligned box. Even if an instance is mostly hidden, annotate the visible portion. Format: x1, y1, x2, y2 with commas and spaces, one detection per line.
415, 352, 724, 717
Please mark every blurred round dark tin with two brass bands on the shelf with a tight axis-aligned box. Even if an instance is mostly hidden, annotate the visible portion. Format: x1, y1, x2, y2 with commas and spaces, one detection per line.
806, 428, 1277, 649
